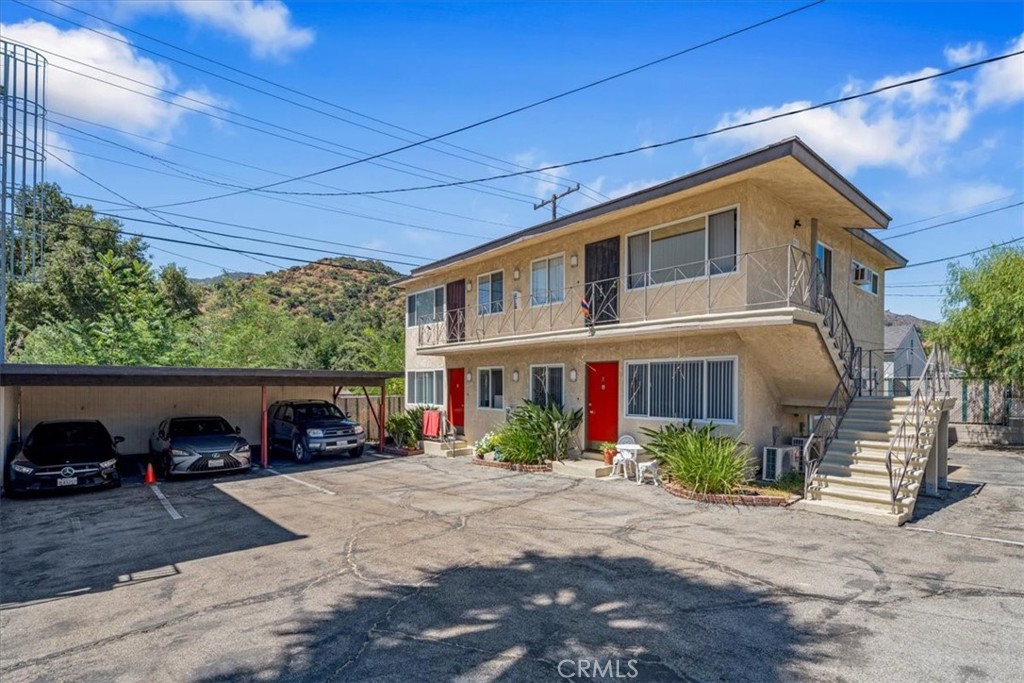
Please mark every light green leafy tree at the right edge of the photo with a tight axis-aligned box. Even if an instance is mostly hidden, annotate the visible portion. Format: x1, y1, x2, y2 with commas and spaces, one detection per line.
936, 248, 1024, 382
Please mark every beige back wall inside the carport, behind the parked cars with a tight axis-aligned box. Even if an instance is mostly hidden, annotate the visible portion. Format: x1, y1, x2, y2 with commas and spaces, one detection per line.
22, 387, 333, 455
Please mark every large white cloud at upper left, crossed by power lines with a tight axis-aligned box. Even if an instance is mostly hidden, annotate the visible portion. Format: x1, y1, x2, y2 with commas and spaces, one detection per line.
0, 19, 217, 140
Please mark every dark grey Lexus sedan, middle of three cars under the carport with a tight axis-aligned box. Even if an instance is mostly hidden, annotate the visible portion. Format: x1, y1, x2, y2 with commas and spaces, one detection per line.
150, 415, 252, 477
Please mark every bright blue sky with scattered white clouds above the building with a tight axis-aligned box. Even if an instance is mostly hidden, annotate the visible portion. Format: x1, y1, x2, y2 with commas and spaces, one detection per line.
0, 0, 1024, 318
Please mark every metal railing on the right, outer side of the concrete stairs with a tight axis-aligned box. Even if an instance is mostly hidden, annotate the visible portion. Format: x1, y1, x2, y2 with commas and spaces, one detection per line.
886, 344, 949, 514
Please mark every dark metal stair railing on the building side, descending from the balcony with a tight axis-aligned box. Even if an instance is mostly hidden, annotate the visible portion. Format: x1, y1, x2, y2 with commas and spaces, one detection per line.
803, 260, 862, 499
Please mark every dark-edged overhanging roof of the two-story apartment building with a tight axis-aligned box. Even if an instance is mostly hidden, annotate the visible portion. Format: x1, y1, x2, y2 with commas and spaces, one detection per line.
395, 137, 906, 285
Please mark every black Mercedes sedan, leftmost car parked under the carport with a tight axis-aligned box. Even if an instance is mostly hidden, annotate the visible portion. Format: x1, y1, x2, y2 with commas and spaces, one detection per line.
4, 420, 124, 494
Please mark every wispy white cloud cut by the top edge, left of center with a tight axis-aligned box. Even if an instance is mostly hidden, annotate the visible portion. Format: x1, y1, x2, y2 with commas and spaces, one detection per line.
129, 0, 315, 59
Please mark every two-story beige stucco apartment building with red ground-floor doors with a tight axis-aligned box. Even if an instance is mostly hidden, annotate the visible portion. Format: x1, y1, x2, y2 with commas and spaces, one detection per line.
399, 138, 906, 453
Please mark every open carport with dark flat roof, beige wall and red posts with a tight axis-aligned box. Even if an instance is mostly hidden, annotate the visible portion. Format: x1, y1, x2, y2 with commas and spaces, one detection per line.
0, 364, 401, 467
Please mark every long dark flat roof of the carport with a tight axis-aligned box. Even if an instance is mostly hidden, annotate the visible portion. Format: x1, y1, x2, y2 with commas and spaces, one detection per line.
0, 362, 402, 387
